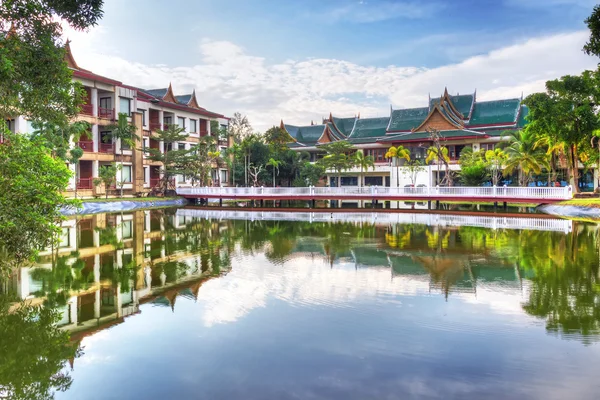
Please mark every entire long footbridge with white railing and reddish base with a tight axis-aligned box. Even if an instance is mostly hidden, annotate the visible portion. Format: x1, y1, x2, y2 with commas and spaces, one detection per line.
177, 186, 572, 204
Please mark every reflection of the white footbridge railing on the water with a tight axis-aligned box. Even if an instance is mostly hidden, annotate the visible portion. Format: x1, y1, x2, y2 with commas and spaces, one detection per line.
177, 209, 573, 233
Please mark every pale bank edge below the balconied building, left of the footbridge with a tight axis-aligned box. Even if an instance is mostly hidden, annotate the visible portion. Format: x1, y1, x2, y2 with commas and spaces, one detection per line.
61, 197, 187, 216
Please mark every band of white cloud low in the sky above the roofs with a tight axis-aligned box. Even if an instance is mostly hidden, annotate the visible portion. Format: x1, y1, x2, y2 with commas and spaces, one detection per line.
63, 28, 598, 130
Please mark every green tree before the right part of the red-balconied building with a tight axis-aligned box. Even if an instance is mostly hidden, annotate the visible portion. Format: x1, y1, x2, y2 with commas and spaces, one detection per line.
144, 125, 190, 196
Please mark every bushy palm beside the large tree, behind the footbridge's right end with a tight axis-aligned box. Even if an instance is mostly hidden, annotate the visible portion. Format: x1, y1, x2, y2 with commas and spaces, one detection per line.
504, 130, 548, 186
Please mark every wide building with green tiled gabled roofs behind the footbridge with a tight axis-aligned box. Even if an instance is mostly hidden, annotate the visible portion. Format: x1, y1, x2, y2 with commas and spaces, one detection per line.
280, 90, 597, 195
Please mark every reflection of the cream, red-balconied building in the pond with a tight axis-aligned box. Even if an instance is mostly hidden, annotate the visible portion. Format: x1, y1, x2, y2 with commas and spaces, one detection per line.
0, 210, 229, 339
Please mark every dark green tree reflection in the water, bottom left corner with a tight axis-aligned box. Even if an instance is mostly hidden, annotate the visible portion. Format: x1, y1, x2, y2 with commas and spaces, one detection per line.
0, 298, 79, 400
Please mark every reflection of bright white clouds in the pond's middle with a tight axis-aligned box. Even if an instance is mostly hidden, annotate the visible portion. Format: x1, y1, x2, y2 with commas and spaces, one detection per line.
198, 252, 523, 326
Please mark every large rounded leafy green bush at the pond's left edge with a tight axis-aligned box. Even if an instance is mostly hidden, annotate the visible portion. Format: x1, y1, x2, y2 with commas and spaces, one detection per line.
0, 128, 76, 274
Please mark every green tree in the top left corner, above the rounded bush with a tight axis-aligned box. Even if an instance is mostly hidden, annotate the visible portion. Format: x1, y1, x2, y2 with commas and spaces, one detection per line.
0, 0, 103, 125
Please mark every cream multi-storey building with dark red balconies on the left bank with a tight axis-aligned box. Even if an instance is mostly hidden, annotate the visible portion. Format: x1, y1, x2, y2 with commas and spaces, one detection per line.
7, 43, 230, 197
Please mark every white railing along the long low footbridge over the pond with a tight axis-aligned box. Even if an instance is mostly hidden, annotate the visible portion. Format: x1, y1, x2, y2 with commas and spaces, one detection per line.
177, 186, 572, 200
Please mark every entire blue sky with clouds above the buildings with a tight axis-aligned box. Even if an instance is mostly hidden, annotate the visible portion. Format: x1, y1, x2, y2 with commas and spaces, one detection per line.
65, 0, 600, 131
